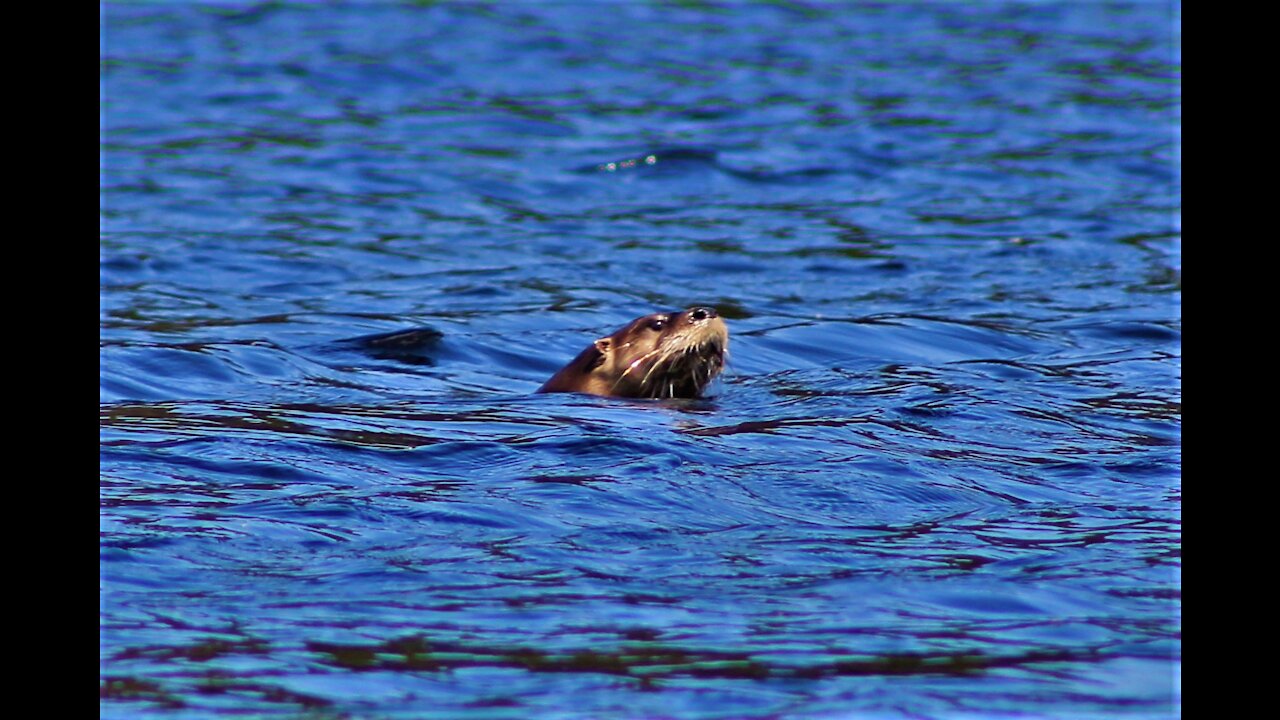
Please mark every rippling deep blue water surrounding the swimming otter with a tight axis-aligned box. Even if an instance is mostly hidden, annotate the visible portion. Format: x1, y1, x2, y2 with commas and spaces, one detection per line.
100, 1, 1181, 719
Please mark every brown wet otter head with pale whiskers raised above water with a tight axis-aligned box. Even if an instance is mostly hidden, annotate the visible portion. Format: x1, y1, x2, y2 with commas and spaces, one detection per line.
538, 307, 728, 398
